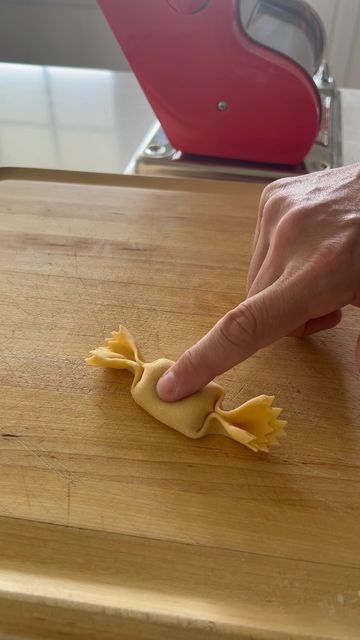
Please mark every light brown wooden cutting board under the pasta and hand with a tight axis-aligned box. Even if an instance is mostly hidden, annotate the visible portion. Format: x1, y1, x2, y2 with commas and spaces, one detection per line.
0, 170, 360, 640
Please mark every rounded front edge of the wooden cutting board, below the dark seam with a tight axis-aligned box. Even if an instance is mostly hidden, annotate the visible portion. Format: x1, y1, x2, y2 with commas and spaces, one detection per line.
0, 517, 357, 640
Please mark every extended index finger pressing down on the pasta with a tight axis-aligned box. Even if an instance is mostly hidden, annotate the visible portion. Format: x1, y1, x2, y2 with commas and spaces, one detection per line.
157, 279, 310, 401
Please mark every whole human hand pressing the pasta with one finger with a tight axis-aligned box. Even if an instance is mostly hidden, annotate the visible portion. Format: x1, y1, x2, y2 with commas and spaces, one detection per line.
157, 164, 360, 401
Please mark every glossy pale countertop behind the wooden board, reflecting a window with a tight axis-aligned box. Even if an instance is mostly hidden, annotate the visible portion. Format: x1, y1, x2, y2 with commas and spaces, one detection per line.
0, 63, 360, 173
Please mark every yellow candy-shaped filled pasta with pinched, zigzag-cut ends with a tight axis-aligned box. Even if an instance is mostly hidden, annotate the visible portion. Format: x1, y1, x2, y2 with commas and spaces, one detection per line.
86, 327, 286, 451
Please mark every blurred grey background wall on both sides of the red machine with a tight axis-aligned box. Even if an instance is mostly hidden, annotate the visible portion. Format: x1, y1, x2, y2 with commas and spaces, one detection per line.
0, 0, 360, 88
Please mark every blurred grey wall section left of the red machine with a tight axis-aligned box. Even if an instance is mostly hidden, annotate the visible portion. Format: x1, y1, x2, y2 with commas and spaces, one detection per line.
0, 0, 127, 69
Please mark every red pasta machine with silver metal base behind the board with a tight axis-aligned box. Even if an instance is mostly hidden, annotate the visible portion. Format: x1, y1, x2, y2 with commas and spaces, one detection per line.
98, 0, 341, 177
